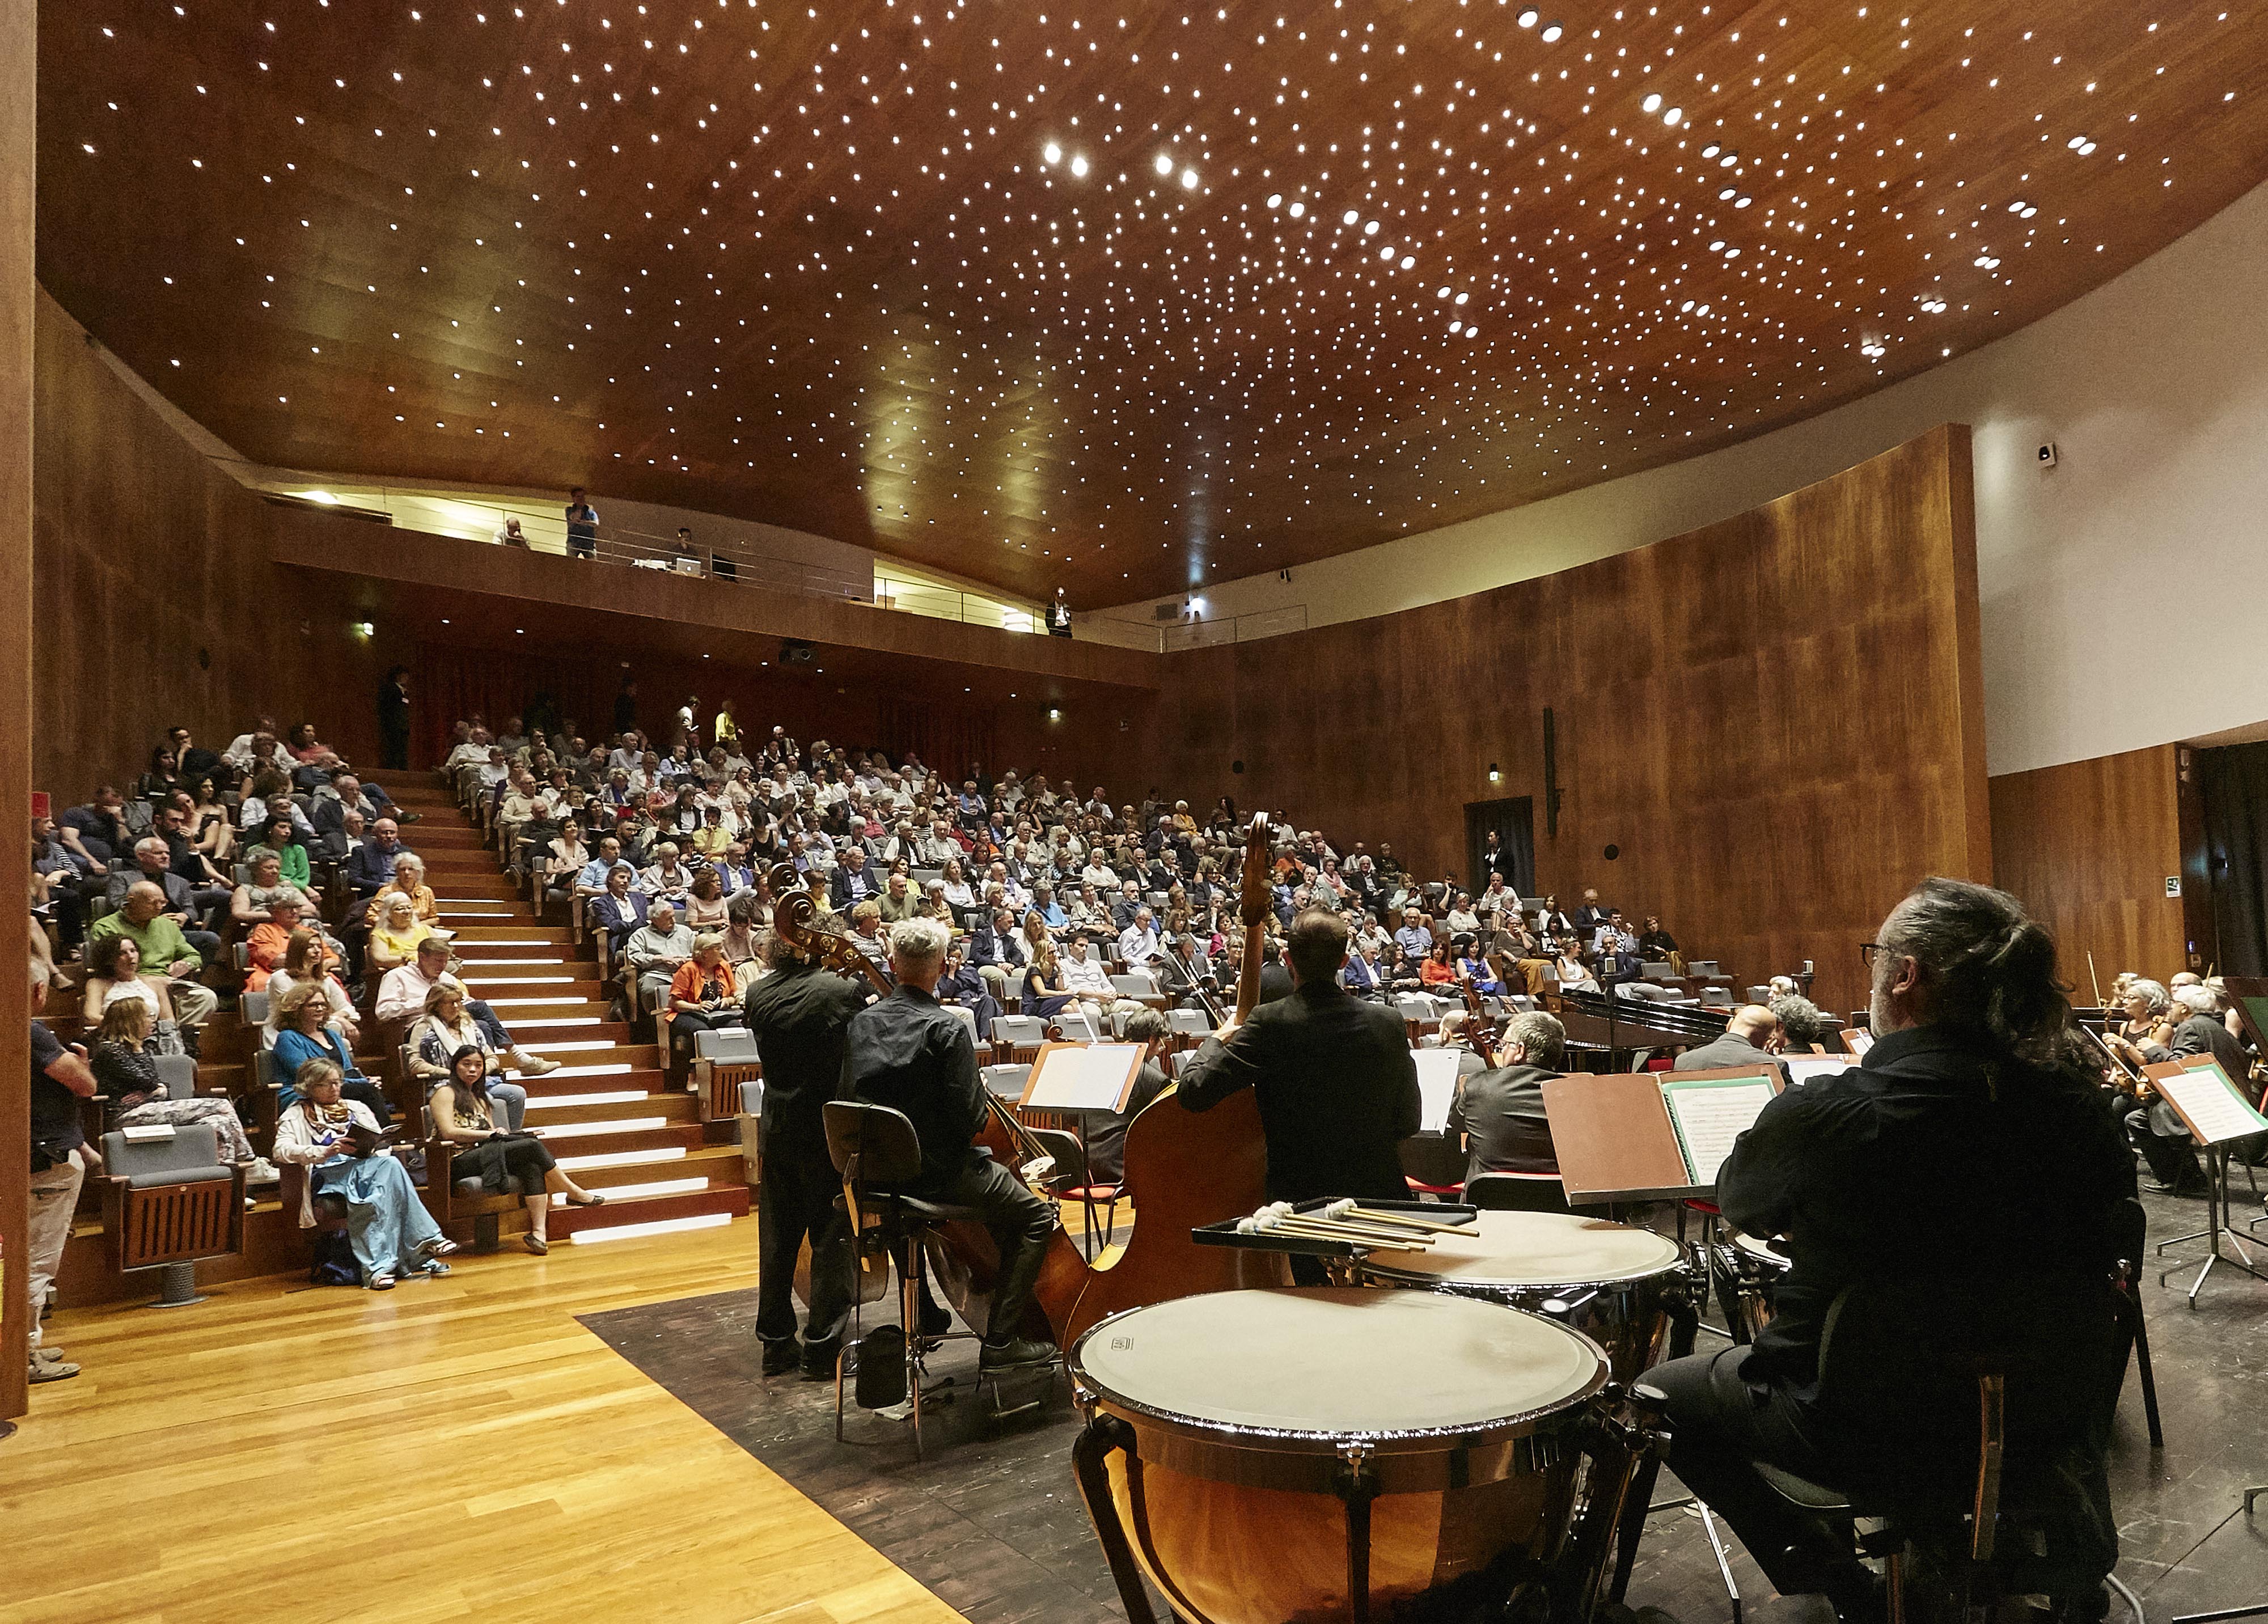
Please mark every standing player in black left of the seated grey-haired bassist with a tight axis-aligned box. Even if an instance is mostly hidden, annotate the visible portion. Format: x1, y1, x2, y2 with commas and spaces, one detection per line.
742, 930, 866, 1381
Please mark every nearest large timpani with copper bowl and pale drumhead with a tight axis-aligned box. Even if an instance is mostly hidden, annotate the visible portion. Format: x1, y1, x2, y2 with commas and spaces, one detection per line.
1070, 1286, 1628, 1624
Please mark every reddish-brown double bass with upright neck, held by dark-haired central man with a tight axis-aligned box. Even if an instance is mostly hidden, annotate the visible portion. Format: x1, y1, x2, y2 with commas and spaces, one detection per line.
1061, 812, 1290, 1352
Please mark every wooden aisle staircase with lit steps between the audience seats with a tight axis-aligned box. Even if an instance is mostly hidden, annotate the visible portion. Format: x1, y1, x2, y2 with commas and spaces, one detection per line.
386, 775, 748, 1241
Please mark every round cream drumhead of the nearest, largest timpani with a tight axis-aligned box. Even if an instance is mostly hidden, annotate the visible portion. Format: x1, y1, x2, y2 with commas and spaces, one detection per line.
1073, 1288, 1606, 1445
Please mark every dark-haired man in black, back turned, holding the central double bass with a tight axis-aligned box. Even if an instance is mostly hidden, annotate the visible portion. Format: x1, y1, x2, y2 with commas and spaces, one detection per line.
1175, 908, 1420, 1202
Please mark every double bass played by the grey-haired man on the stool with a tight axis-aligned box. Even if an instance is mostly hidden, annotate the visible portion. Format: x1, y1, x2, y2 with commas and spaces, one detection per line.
767, 864, 1086, 1343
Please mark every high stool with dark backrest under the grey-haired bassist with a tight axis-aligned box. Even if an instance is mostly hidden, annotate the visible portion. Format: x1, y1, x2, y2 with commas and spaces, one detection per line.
821, 1100, 1057, 1461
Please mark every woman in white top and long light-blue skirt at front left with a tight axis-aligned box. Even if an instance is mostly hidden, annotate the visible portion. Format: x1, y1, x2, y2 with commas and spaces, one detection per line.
274, 1052, 456, 1291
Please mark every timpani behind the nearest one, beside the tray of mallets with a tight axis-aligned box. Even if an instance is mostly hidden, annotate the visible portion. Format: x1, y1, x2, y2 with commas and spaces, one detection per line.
1356, 1211, 1692, 1384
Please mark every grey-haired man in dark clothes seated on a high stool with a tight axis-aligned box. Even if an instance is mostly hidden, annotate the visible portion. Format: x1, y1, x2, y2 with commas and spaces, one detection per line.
844, 919, 1057, 1368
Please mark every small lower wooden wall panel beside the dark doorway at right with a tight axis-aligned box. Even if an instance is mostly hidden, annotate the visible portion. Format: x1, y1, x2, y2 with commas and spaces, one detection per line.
1991, 744, 2189, 1003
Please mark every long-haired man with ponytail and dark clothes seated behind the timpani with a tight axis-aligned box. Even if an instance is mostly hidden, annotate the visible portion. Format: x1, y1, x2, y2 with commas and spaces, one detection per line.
1647, 878, 2134, 1617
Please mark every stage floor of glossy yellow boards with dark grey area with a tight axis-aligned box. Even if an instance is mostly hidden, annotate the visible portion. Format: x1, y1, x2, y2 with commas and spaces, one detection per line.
0, 1195, 2268, 1624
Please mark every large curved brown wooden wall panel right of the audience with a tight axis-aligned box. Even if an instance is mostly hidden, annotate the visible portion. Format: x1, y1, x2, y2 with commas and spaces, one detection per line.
1154, 426, 1991, 1010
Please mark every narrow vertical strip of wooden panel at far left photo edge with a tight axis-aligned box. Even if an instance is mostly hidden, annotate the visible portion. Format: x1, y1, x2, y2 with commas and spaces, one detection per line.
0, 0, 39, 1420
